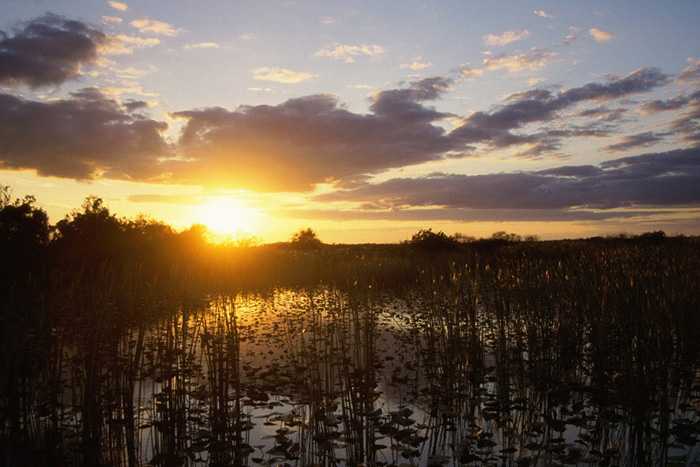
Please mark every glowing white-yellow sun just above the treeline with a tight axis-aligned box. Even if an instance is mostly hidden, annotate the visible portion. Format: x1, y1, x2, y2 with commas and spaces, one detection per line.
195, 197, 262, 238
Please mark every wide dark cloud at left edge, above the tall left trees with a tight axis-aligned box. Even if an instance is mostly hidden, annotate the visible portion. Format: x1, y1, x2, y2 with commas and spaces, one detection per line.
0, 88, 168, 180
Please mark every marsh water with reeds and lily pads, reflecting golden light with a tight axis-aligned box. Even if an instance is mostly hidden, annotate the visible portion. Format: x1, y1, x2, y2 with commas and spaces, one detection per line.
32, 287, 700, 466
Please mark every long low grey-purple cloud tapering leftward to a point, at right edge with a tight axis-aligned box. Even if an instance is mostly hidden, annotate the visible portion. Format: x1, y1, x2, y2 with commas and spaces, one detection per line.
318, 149, 700, 210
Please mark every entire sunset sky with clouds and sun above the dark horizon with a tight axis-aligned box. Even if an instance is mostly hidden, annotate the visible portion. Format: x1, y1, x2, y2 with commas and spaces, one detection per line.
0, 0, 700, 243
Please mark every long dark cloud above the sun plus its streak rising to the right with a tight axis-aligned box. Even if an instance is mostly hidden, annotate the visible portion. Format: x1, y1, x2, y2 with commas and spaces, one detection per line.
163, 68, 668, 191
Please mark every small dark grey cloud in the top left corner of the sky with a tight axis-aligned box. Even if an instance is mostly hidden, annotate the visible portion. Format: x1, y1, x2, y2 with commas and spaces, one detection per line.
0, 14, 107, 88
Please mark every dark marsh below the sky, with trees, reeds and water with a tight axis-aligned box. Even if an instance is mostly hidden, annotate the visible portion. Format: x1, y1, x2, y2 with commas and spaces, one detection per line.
0, 188, 700, 466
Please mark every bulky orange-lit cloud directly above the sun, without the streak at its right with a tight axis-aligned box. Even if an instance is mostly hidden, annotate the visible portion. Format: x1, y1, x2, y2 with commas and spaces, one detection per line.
168, 78, 453, 191
